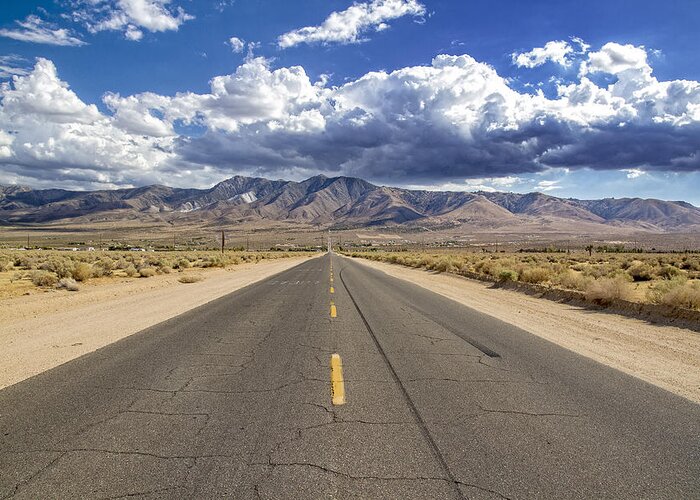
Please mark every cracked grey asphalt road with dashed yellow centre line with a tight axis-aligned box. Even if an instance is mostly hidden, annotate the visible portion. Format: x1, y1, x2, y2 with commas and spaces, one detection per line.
0, 255, 700, 499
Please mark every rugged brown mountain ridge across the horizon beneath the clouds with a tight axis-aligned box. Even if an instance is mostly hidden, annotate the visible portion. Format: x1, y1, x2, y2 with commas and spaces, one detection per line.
0, 175, 700, 232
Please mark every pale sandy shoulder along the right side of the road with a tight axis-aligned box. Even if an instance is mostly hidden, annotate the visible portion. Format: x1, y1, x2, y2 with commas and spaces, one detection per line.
356, 259, 700, 403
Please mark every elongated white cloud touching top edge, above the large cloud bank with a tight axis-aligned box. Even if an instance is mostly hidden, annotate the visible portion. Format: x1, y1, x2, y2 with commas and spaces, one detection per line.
277, 0, 426, 48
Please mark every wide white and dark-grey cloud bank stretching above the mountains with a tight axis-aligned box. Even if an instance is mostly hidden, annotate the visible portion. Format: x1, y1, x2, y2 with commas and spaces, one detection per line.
0, 43, 700, 188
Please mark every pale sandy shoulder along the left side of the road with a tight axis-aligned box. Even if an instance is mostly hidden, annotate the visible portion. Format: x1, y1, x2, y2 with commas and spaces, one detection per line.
0, 257, 314, 389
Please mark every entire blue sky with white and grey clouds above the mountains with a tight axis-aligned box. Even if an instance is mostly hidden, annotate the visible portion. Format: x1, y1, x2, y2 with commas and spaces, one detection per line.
0, 0, 700, 205
